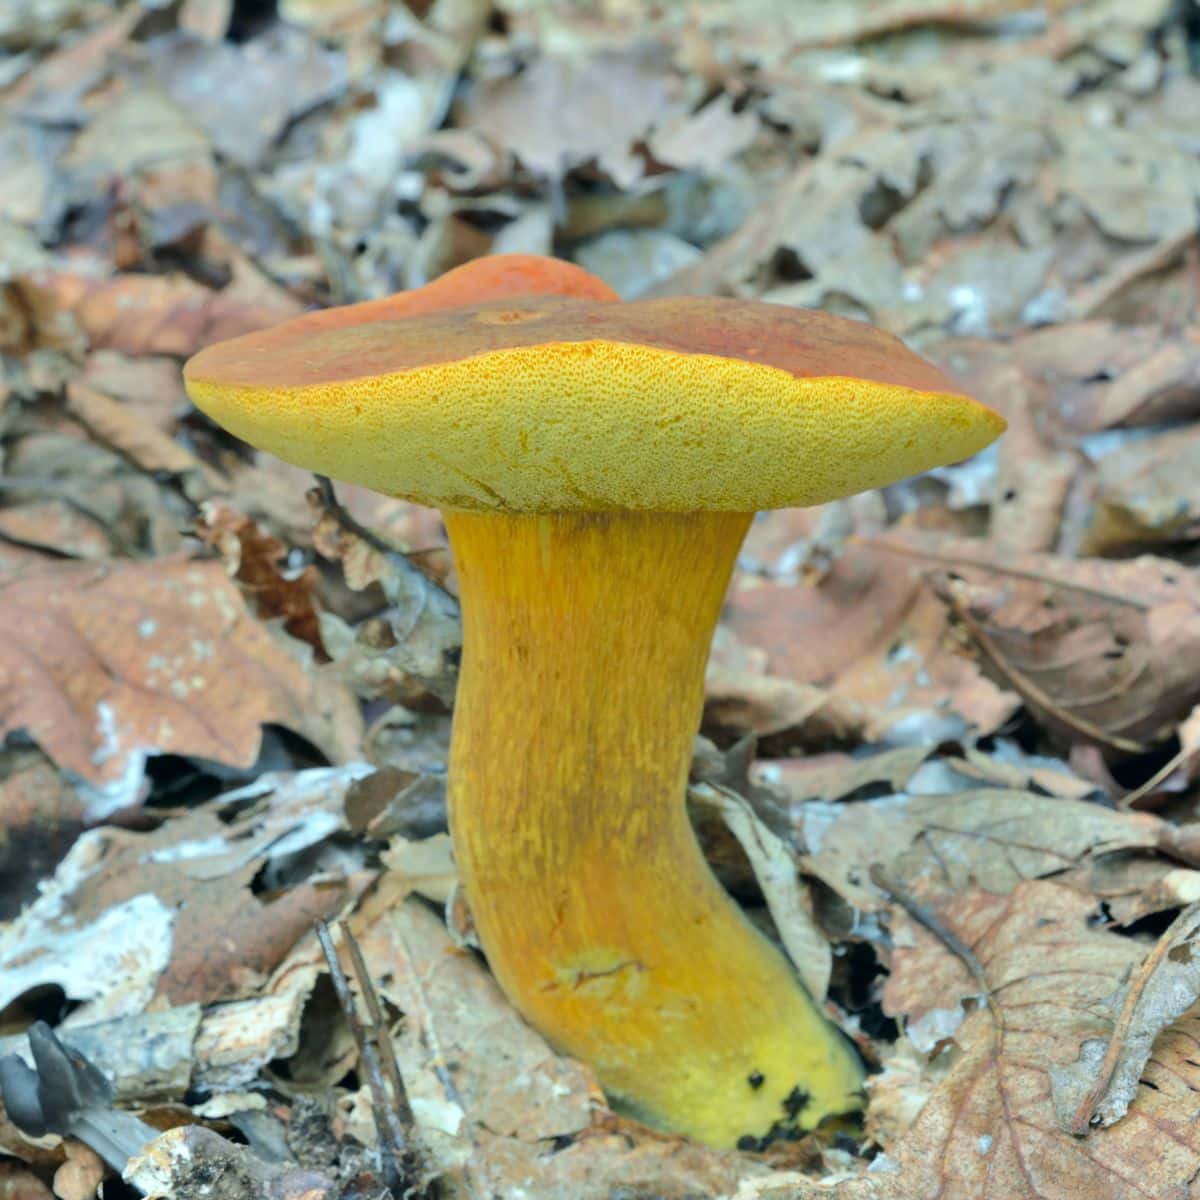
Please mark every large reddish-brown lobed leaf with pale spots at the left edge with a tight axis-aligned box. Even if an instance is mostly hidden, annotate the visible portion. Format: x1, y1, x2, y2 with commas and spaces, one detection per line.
0, 563, 361, 806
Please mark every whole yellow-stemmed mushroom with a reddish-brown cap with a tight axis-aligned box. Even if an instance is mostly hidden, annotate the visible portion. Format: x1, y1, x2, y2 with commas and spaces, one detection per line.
185, 250, 1004, 1146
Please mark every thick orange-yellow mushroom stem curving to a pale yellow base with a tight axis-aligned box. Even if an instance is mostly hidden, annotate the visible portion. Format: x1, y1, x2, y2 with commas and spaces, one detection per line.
445, 512, 862, 1146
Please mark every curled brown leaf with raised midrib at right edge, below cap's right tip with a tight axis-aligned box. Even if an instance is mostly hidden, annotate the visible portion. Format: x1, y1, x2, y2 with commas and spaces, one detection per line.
872, 534, 1200, 754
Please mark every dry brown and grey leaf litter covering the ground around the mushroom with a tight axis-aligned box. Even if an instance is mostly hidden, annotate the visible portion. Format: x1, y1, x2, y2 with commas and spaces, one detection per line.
0, 0, 1200, 1200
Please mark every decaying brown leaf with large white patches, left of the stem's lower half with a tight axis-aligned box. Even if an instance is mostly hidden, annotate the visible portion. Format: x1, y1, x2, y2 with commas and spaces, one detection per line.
0, 764, 370, 1022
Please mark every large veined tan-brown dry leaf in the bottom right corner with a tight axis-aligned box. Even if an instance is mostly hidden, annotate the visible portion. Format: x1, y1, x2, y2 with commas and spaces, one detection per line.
868, 882, 1200, 1200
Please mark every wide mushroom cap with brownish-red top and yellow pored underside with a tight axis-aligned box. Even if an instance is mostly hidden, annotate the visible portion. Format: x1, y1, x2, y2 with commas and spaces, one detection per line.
184, 288, 1004, 512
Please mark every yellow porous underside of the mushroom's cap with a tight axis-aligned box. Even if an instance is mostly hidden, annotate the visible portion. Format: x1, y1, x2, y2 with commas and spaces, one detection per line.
186, 305, 1004, 512
